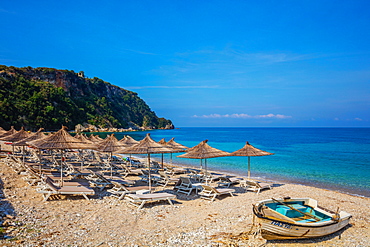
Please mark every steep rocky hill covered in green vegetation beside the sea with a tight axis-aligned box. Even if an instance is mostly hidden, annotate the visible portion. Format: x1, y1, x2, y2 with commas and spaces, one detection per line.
0, 65, 172, 130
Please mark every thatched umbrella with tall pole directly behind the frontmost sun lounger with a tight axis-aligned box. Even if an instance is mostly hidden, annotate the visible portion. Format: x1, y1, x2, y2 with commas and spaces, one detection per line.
117, 133, 172, 190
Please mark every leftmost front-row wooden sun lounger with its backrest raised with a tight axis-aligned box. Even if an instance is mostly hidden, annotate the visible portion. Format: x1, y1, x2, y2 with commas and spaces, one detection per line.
37, 177, 95, 201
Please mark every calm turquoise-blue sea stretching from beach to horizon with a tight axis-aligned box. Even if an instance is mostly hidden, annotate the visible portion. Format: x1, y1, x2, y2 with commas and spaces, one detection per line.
99, 128, 370, 197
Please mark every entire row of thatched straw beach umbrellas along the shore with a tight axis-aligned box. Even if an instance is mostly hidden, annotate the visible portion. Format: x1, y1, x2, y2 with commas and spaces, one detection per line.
0, 127, 273, 181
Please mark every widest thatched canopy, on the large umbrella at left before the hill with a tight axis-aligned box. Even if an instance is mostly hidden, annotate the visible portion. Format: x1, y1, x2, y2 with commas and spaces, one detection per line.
27, 126, 94, 149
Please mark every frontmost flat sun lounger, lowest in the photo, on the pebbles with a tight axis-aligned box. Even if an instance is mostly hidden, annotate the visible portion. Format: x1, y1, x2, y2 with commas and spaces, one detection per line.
125, 192, 176, 210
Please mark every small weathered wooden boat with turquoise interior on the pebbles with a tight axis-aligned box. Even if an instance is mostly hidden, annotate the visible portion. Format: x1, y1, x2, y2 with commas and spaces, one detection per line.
253, 197, 352, 240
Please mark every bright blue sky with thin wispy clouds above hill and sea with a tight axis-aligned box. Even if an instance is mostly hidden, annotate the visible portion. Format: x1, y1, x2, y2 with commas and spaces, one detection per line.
0, 0, 370, 127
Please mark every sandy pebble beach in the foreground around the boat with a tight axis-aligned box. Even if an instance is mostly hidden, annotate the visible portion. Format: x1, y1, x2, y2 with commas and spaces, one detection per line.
0, 155, 370, 246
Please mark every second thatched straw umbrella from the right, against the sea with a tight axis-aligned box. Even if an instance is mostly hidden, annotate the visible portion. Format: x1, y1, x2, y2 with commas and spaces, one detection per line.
177, 140, 230, 178
